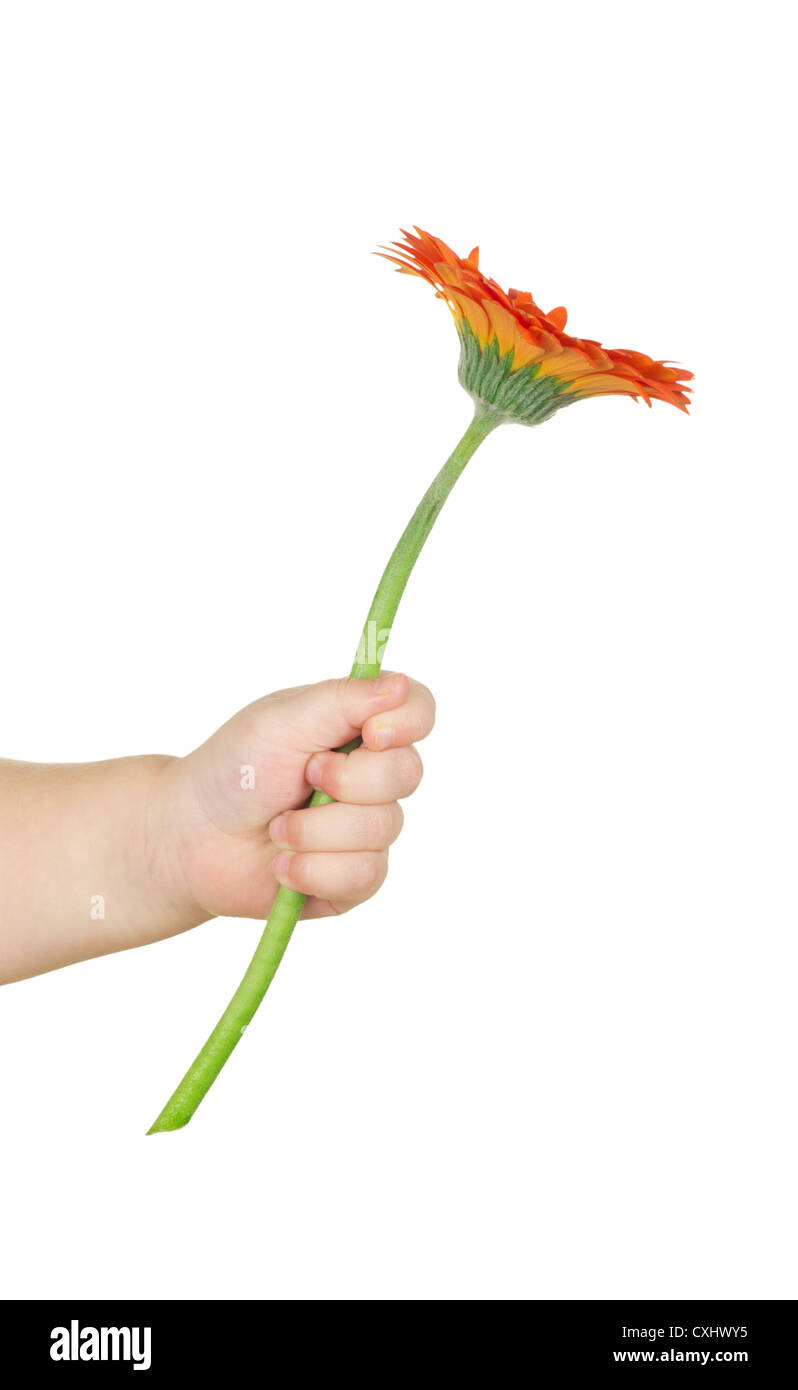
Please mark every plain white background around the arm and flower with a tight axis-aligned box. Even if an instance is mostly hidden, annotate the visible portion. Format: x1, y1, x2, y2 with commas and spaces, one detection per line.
0, 0, 798, 1298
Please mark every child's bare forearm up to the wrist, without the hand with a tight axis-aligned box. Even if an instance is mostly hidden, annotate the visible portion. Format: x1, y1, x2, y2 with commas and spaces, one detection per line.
0, 756, 202, 984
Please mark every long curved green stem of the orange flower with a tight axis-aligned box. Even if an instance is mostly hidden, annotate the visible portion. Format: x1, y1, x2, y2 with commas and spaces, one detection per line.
147, 404, 502, 1134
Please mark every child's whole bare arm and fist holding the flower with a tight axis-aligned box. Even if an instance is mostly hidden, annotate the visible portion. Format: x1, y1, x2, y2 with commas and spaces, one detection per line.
0, 674, 434, 984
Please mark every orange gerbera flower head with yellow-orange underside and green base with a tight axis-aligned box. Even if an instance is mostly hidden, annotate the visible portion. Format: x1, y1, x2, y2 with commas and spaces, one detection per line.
380, 227, 692, 425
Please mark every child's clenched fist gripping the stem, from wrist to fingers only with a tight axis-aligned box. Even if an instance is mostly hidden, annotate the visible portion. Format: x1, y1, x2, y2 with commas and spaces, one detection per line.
156, 673, 435, 924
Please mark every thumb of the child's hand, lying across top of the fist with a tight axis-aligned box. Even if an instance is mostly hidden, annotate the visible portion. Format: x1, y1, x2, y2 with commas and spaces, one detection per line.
256, 671, 410, 753
